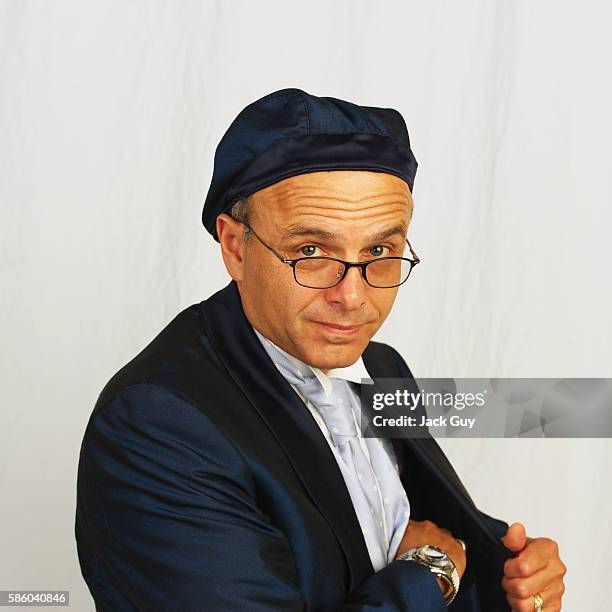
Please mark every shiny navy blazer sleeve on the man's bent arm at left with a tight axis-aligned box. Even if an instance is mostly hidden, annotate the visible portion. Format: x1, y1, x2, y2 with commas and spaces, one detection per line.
75, 384, 446, 612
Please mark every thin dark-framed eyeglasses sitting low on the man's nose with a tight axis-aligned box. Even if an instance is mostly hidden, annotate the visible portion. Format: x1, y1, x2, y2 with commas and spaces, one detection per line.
243, 223, 421, 289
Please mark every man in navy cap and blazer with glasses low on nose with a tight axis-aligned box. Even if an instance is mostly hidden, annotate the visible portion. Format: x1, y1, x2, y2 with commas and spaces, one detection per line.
75, 89, 565, 612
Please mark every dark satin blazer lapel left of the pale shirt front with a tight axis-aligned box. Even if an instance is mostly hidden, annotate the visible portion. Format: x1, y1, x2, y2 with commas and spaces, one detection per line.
201, 281, 374, 591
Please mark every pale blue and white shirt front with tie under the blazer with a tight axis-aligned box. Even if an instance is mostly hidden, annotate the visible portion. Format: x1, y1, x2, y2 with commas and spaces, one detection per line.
253, 328, 410, 571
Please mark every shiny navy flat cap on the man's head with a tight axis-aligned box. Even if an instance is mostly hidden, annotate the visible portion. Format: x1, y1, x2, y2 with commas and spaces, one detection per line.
202, 88, 417, 242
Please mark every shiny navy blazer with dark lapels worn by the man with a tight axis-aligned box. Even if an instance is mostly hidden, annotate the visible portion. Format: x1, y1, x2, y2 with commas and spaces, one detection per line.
75, 281, 511, 612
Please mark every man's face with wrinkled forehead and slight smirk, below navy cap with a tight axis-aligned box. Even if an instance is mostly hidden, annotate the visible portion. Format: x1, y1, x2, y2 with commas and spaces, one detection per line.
221, 170, 412, 371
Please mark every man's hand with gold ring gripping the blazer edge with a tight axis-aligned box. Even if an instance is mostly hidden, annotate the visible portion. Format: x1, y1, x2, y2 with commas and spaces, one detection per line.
502, 523, 567, 612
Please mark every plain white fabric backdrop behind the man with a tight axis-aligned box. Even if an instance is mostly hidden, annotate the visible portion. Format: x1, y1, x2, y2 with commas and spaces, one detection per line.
0, 0, 612, 612
